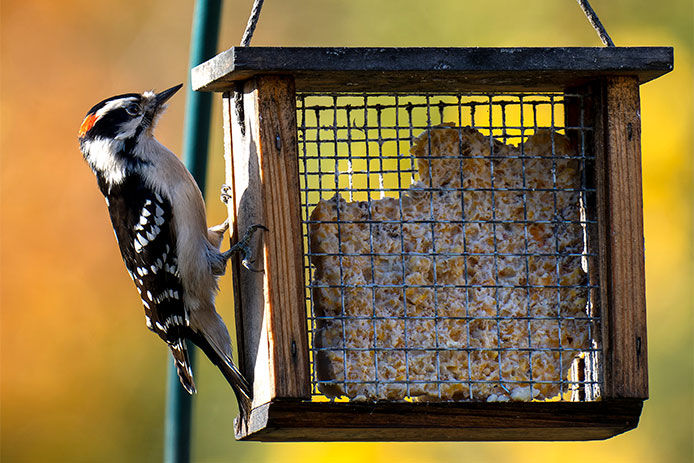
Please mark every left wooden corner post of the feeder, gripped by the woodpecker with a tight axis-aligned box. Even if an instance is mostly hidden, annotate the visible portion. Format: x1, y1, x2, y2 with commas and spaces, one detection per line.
222, 76, 310, 407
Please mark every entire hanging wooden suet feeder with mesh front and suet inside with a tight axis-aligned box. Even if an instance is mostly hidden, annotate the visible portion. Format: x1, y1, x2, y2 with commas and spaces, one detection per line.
192, 47, 673, 441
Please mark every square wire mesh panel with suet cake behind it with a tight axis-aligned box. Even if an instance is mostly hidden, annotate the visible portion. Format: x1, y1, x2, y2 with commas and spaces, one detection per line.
297, 93, 601, 401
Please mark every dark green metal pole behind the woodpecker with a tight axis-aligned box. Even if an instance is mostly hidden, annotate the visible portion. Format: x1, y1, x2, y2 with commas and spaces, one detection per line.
164, 0, 222, 463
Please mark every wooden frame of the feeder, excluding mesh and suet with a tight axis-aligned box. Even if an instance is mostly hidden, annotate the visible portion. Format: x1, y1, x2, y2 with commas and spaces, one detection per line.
192, 47, 673, 441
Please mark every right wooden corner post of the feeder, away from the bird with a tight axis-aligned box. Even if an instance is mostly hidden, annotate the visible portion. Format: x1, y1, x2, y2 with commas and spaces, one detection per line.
596, 76, 648, 400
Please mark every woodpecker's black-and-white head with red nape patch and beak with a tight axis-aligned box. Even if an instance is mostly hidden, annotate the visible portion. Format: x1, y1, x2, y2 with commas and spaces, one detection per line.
78, 84, 183, 140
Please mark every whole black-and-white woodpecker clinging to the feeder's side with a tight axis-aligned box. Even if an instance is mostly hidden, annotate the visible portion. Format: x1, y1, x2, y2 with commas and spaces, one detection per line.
79, 85, 258, 417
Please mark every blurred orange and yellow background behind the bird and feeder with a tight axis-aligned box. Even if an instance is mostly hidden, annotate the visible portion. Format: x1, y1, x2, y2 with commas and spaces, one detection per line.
0, 0, 694, 463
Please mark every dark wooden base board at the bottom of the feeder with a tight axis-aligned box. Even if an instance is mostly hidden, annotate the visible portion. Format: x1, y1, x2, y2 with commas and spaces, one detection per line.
236, 400, 643, 441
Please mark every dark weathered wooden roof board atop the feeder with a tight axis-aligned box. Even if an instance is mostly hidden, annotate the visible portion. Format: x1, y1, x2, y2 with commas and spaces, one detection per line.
191, 47, 673, 92
